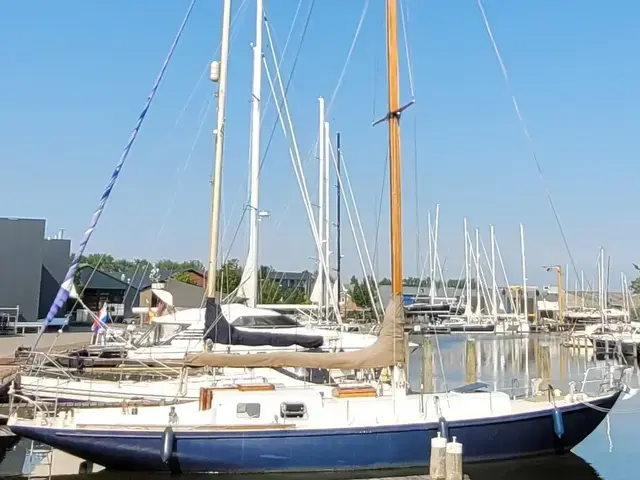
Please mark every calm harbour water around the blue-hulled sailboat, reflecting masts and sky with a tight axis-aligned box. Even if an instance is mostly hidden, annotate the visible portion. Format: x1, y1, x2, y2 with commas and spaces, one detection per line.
3, 334, 640, 480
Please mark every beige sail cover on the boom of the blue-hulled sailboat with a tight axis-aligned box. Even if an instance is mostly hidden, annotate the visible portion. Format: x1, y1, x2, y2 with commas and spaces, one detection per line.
185, 296, 405, 369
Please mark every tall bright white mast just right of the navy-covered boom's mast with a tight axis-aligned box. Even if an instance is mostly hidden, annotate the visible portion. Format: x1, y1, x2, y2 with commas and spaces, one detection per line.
239, 0, 264, 307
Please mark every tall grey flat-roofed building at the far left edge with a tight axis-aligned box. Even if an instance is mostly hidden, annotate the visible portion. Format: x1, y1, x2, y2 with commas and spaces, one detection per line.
0, 218, 71, 322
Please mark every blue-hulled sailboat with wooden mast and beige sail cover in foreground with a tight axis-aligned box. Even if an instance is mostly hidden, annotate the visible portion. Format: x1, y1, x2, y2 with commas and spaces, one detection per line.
8, 0, 624, 473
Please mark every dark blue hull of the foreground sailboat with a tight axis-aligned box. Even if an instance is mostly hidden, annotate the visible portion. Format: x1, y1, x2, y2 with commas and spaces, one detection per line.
11, 392, 620, 473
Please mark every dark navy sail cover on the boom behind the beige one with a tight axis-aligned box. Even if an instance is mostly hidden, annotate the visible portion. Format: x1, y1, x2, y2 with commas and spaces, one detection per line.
204, 298, 324, 348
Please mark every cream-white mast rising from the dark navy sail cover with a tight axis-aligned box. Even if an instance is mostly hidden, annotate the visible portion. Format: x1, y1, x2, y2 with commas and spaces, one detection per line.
207, 0, 231, 298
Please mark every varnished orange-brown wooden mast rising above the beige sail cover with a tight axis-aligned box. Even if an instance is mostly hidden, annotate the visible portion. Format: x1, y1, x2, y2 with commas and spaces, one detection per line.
386, 0, 402, 301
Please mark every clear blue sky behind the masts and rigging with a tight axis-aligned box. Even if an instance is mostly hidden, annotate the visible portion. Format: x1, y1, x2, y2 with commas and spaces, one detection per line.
0, 0, 640, 286
